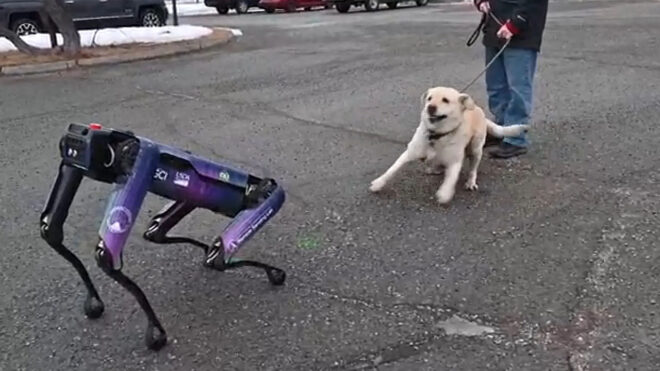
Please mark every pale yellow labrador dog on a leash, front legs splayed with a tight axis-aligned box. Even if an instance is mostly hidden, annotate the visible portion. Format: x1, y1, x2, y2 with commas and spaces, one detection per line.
369, 86, 528, 204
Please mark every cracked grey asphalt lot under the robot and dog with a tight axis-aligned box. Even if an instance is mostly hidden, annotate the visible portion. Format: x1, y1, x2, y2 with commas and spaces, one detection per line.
0, 1, 660, 371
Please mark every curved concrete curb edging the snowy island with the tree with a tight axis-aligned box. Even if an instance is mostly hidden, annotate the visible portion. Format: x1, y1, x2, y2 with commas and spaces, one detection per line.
0, 27, 243, 76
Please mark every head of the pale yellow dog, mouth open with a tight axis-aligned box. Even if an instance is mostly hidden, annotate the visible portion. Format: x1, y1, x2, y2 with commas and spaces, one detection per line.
421, 86, 475, 129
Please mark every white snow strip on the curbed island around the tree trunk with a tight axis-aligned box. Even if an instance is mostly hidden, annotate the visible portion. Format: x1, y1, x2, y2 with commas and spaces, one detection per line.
0, 25, 213, 52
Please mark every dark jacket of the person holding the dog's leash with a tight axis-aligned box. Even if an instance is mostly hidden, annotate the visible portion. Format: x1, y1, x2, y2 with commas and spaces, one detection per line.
473, 0, 548, 51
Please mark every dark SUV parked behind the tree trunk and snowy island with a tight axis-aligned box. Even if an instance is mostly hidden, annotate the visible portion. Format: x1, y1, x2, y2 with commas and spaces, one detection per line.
0, 0, 169, 35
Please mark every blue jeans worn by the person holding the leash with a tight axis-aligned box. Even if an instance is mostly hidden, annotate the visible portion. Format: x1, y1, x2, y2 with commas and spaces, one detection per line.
486, 47, 538, 147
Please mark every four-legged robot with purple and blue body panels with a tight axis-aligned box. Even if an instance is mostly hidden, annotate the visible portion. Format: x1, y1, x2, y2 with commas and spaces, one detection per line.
40, 124, 286, 350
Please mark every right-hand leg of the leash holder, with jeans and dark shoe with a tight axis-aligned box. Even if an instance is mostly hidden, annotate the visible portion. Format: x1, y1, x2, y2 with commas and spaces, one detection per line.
491, 48, 537, 158
